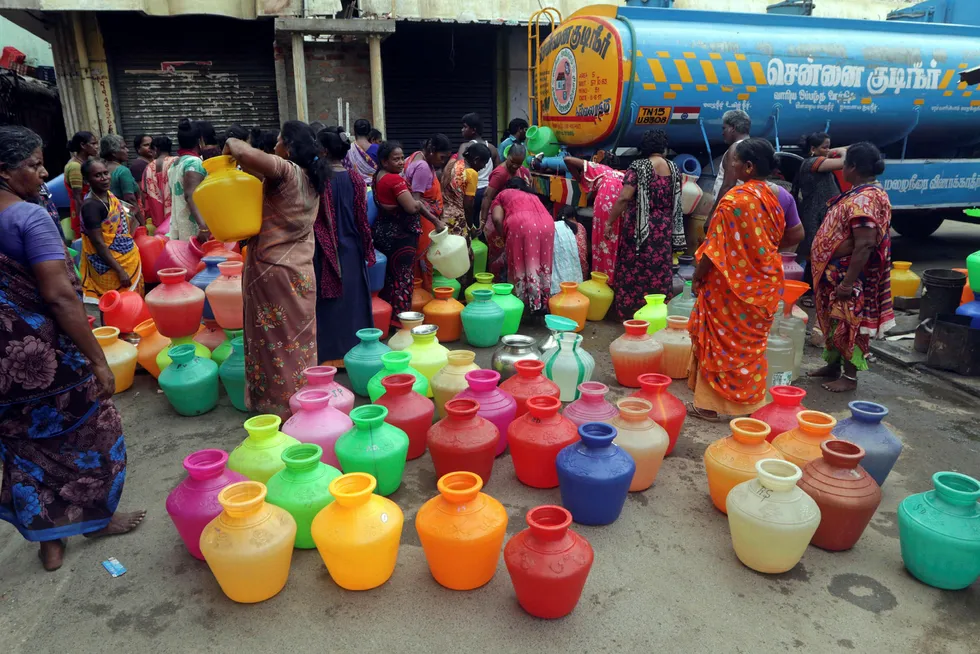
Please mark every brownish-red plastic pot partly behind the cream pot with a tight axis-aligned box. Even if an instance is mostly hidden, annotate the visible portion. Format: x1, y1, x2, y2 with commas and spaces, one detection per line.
797, 440, 881, 552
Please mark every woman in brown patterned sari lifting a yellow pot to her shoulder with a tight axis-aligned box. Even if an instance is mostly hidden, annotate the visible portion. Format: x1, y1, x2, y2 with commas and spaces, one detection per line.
224, 120, 326, 417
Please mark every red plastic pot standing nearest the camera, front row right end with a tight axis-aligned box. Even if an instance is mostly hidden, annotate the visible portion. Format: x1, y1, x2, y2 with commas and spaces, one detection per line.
504, 505, 595, 619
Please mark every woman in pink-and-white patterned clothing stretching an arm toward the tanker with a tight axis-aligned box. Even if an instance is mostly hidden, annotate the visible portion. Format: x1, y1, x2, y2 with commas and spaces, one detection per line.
565, 157, 625, 281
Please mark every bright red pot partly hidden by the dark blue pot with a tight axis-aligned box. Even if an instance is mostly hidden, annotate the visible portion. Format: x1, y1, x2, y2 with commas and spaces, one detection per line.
507, 395, 578, 488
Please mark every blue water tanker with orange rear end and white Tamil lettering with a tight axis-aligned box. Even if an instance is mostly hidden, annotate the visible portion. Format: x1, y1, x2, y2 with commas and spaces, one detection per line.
529, 0, 980, 236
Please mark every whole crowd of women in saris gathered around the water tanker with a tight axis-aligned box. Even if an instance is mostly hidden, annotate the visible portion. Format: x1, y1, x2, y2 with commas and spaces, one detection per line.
0, 106, 892, 570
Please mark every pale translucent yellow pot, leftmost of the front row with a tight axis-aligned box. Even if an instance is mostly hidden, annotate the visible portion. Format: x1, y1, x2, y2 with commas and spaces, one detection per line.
201, 481, 296, 603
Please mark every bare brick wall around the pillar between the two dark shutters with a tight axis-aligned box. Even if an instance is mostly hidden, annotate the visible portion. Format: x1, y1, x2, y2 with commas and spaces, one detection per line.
283, 41, 372, 131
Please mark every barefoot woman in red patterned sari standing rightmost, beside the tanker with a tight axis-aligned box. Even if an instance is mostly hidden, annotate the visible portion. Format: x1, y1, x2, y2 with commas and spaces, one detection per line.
810, 143, 895, 393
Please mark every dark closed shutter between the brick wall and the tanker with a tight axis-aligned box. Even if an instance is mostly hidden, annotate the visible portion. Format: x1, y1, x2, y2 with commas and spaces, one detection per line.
381, 22, 497, 154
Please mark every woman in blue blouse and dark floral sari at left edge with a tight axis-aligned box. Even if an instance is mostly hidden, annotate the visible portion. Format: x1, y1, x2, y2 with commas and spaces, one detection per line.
0, 127, 146, 570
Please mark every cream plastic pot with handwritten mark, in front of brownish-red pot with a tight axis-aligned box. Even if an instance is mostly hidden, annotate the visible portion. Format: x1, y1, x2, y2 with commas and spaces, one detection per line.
727, 459, 820, 574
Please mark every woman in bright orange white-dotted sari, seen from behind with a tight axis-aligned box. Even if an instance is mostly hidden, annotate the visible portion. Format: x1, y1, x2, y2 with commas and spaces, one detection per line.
688, 138, 785, 421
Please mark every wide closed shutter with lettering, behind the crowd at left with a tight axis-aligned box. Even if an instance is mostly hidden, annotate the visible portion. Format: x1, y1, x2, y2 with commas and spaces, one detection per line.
99, 12, 280, 149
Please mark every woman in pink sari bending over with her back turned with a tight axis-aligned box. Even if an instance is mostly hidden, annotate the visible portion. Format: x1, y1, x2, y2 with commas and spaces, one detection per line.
486, 177, 555, 312
